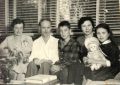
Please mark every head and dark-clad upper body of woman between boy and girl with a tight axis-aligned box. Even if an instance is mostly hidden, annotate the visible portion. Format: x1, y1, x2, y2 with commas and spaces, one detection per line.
77, 17, 94, 60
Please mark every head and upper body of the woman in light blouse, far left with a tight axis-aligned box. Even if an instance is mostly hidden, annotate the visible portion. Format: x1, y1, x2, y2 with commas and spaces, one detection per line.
0, 18, 32, 56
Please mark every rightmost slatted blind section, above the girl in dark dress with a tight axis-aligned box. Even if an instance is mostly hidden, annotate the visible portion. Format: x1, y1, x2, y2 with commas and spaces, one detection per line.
99, 0, 120, 33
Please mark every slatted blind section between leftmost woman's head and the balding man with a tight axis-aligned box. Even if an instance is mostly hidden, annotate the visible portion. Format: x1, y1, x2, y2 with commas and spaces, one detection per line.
16, 0, 38, 30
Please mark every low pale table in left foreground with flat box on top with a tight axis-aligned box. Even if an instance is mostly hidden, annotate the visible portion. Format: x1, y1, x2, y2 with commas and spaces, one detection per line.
0, 74, 58, 85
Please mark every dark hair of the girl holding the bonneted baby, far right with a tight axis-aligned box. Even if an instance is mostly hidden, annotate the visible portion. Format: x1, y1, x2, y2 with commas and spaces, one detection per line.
95, 23, 116, 44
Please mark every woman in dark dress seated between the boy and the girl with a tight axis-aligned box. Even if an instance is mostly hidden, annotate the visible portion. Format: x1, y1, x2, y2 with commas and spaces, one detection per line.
77, 17, 94, 83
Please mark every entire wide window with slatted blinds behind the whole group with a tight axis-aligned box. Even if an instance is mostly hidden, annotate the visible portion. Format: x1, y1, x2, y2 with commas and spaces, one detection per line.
0, 0, 120, 34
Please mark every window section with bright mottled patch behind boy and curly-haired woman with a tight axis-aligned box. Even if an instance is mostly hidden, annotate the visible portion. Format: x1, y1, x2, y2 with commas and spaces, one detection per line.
57, 0, 96, 35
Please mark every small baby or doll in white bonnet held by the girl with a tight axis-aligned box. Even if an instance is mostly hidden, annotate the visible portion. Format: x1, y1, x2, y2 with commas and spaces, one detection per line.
85, 37, 110, 71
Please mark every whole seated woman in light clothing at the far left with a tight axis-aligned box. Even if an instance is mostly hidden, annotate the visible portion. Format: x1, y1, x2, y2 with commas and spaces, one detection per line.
0, 18, 33, 80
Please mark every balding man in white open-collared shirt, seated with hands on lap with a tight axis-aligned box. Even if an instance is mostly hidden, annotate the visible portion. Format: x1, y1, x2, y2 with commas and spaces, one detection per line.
26, 19, 59, 77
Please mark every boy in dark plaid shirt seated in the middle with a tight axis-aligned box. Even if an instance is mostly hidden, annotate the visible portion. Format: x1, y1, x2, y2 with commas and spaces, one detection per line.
52, 21, 83, 85
